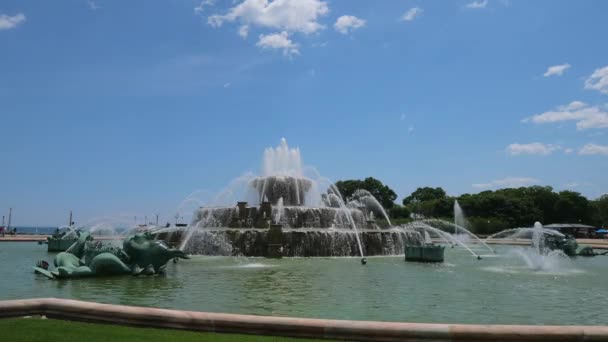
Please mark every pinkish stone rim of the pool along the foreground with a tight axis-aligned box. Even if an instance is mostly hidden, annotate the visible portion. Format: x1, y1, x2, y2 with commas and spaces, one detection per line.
0, 298, 608, 341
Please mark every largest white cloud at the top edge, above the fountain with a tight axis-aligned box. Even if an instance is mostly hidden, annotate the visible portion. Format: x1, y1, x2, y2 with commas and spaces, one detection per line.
207, 0, 329, 34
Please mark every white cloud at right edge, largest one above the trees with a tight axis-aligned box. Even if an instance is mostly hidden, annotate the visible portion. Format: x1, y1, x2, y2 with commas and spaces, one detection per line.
522, 101, 608, 130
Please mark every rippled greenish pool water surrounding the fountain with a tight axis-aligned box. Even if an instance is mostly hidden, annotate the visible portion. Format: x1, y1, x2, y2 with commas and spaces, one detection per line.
0, 242, 608, 325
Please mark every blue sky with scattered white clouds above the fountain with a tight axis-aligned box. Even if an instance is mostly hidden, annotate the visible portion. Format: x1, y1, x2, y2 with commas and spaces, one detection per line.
0, 0, 608, 225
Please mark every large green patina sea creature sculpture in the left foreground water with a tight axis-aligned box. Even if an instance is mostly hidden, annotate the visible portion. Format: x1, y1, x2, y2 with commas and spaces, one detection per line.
34, 232, 188, 279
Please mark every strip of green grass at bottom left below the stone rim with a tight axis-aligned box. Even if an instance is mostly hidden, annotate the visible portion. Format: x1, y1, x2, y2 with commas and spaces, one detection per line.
0, 317, 332, 342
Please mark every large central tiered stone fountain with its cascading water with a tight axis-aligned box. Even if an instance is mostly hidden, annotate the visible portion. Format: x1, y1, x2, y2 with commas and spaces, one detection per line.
156, 139, 424, 256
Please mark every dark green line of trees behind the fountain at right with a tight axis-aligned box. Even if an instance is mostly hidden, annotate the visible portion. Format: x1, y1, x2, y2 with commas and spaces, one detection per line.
336, 177, 608, 234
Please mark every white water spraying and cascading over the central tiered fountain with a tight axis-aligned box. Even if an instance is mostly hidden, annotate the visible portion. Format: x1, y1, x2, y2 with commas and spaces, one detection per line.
180, 138, 380, 258
